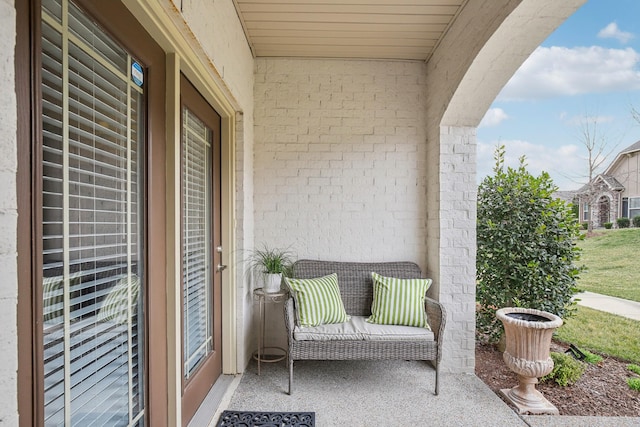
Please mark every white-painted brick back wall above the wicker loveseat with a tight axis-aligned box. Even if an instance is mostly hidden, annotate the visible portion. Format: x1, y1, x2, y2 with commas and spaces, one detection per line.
254, 59, 427, 266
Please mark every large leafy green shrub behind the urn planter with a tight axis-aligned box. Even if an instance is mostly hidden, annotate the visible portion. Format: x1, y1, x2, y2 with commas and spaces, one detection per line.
476, 146, 581, 342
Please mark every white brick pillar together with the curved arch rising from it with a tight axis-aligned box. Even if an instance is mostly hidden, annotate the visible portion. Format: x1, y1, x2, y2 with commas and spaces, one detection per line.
420, 0, 585, 373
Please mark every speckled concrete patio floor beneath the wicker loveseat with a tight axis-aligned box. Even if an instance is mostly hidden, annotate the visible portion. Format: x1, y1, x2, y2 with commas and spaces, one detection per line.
205, 361, 640, 427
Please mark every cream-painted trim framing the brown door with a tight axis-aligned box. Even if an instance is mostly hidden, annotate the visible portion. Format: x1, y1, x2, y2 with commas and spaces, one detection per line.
130, 0, 240, 425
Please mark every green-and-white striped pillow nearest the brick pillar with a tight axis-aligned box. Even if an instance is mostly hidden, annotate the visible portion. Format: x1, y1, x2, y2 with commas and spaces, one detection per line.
367, 273, 431, 329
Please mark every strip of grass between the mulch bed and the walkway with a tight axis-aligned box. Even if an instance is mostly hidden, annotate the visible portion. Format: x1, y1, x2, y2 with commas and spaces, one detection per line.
555, 306, 640, 363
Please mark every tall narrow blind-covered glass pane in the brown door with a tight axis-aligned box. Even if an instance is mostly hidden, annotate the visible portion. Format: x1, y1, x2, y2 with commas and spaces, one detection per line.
182, 108, 213, 379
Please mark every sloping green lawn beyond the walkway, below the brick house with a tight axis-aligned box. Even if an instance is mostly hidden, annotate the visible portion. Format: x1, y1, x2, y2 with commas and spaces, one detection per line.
578, 228, 640, 302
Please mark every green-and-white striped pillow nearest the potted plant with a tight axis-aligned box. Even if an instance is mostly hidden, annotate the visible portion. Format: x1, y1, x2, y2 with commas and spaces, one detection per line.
284, 273, 349, 326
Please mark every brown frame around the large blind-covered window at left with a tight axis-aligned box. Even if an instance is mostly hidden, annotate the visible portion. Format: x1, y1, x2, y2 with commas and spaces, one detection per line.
15, 0, 168, 426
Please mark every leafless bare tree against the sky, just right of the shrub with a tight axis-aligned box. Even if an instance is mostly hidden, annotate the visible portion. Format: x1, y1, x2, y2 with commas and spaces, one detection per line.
578, 115, 616, 233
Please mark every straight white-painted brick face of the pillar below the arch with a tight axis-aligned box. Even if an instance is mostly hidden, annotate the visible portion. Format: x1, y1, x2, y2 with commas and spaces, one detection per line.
438, 126, 477, 373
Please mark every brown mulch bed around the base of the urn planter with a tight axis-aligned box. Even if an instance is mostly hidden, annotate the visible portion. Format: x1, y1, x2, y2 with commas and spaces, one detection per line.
475, 342, 640, 417
